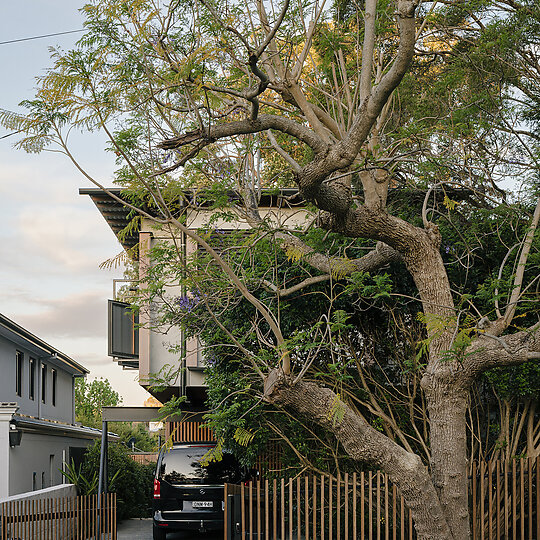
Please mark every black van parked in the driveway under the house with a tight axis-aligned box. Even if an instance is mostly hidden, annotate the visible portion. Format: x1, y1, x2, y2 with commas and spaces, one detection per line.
153, 444, 245, 540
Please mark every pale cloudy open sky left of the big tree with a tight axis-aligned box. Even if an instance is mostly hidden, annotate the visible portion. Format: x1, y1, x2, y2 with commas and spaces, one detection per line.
0, 0, 152, 406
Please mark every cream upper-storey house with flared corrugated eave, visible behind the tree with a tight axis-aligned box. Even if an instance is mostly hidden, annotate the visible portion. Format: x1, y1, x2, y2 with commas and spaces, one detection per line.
79, 188, 305, 407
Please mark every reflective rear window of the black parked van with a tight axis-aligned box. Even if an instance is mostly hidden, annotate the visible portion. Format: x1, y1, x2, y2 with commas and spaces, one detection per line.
160, 447, 243, 484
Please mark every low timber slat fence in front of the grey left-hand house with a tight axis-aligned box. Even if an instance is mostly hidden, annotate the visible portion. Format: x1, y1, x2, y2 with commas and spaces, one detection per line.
0, 493, 116, 540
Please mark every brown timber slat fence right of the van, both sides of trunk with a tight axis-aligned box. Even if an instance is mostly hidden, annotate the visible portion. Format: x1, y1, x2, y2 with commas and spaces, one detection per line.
225, 458, 540, 540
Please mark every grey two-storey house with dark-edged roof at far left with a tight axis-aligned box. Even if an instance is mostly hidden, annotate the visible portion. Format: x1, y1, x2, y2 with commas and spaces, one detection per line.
0, 314, 105, 499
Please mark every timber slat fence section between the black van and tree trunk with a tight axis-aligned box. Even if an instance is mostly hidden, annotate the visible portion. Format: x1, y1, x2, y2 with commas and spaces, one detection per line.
225, 471, 416, 540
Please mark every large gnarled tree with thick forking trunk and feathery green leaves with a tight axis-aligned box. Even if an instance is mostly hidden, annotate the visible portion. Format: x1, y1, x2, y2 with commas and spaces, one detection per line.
2, 0, 540, 540
